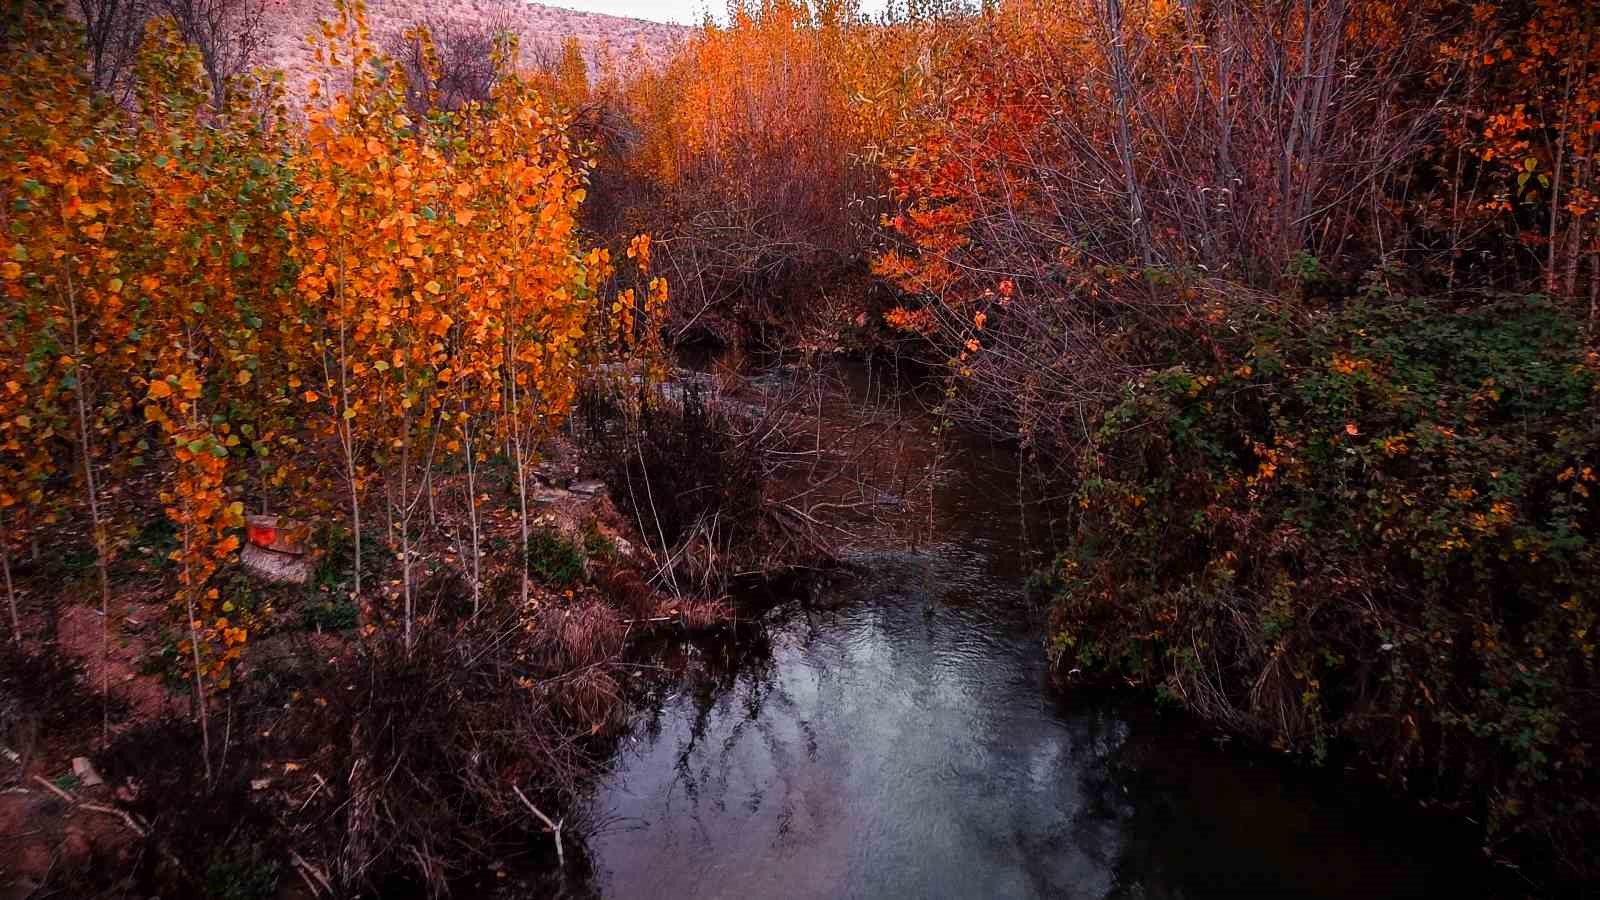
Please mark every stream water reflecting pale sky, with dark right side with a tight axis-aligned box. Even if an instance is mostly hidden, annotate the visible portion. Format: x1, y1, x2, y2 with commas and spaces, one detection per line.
576, 368, 1486, 898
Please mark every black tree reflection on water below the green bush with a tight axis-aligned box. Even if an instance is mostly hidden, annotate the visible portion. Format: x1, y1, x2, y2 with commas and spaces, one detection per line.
1067, 705, 1486, 900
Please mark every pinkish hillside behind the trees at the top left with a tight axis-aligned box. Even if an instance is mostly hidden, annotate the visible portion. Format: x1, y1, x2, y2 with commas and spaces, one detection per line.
261, 0, 686, 90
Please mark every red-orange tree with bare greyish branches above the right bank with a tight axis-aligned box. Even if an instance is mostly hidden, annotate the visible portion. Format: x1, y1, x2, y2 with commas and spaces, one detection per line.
859, 0, 1442, 440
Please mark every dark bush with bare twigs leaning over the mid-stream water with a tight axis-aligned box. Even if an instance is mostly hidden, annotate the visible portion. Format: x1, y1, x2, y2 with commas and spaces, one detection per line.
579, 357, 928, 597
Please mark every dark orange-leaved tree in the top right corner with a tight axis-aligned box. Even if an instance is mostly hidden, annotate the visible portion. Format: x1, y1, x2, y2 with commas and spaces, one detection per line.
1427, 0, 1600, 305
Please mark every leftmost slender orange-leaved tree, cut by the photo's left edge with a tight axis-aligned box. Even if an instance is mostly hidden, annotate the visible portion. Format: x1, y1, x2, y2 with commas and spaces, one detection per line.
0, 1, 138, 730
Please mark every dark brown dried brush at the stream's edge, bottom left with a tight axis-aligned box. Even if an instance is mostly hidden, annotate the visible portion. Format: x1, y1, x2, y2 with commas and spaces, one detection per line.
94, 597, 627, 898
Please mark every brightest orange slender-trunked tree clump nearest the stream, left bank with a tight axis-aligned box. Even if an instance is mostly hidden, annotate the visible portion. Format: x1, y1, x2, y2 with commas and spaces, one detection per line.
291, 5, 610, 630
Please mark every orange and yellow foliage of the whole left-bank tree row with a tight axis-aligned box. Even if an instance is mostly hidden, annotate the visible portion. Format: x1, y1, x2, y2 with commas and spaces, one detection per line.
0, 3, 667, 659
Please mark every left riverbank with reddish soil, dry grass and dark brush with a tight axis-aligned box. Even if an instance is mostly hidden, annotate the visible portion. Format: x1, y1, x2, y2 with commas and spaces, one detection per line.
0, 422, 734, 898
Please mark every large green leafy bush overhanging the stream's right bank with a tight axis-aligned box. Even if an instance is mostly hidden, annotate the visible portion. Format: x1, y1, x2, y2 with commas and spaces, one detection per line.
1054, 295, 1600, 874
